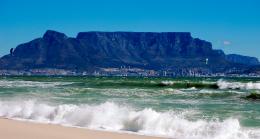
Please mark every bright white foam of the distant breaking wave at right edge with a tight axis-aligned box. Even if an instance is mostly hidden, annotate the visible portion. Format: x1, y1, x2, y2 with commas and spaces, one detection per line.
217, 80, 260, 89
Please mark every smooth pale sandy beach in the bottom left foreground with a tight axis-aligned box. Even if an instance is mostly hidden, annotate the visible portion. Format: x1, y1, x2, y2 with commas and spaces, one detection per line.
0, 119, 162, 139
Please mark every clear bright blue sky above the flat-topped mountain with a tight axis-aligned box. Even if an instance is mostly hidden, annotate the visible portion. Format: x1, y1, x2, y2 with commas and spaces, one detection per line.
0, 0, 260, 58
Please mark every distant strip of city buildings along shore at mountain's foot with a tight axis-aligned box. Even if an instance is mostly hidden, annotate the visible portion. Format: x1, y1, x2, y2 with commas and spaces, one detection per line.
0, 66, 260, 77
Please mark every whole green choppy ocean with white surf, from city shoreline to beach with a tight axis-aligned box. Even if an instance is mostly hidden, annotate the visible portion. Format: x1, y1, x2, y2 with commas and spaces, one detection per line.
0, 76, 260, 139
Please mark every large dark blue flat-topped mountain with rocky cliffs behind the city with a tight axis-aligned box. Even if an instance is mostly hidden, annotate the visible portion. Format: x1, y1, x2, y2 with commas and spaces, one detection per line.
0, 30, 256, 70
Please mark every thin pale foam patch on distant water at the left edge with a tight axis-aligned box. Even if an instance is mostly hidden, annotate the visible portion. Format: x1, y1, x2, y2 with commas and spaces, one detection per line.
0, 80, 72, 88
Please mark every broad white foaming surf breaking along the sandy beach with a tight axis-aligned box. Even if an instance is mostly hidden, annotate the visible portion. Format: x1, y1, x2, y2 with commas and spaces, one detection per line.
0, 100, 260, 139
